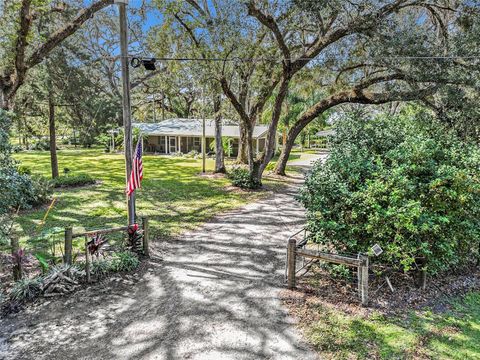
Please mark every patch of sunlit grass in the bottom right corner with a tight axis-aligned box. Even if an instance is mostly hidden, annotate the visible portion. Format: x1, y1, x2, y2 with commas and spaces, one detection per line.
305, 292, 480, 360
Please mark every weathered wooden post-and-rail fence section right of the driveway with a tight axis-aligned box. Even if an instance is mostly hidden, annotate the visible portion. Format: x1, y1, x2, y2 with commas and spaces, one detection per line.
286, 229, 368, 306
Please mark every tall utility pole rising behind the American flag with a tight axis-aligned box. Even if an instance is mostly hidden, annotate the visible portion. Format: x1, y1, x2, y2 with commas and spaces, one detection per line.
116, 0, 135, 225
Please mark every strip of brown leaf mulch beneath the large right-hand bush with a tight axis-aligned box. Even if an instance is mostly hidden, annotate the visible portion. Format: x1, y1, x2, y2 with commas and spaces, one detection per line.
280, 265, 480, 316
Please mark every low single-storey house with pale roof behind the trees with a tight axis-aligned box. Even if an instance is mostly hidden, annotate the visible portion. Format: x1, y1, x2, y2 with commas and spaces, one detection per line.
132, 118, 276, 156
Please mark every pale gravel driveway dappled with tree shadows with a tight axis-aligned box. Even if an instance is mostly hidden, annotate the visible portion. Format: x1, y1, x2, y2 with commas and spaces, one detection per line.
0, 167, 322, 359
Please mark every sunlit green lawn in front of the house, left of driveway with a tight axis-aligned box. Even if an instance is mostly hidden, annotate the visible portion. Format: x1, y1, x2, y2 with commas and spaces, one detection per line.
11, 149, 272, 247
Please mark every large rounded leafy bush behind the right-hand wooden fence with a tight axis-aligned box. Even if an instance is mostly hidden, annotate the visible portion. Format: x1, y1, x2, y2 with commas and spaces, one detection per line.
300, 114, 480, 273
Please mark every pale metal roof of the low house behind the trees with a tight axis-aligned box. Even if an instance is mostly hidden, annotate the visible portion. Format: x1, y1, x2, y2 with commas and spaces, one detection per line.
132, 118, 268, 138
